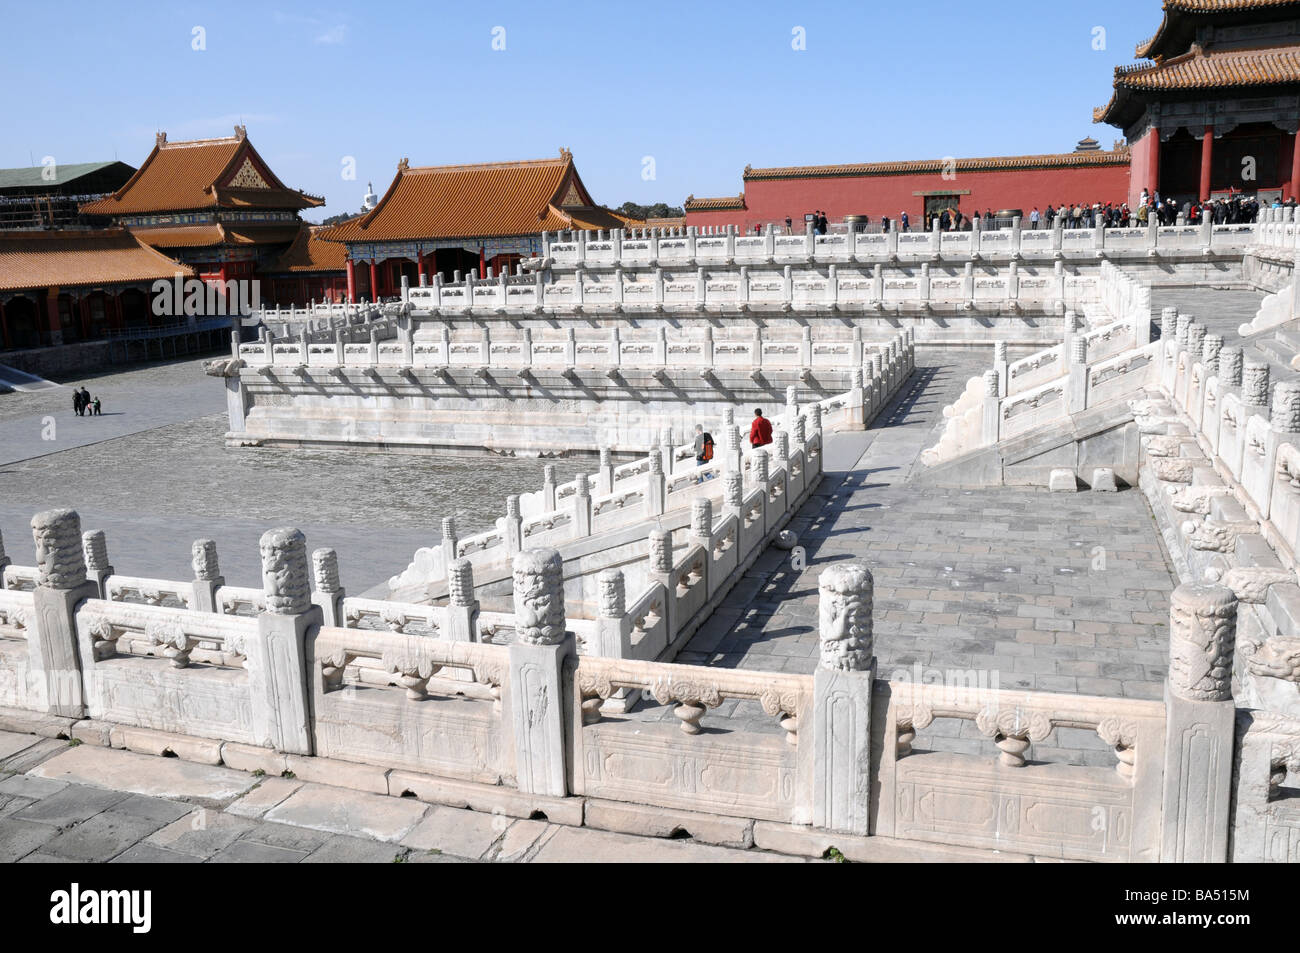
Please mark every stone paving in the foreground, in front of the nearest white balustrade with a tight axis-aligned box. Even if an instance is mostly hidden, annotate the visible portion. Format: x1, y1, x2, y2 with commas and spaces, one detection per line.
0, 732, 803, 863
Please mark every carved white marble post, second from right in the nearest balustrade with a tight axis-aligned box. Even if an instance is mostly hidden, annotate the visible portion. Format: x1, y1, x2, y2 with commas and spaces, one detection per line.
800, 563, 875, 835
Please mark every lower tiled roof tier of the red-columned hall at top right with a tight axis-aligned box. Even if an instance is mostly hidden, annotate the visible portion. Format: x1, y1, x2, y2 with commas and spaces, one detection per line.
1092, 46, 1300, 122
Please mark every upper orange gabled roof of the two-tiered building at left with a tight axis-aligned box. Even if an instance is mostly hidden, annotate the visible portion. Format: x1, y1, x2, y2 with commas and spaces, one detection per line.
82, 127, 325, 216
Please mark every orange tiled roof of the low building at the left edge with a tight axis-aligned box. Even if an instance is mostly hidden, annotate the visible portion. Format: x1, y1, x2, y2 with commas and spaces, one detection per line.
0, 229, 194, 291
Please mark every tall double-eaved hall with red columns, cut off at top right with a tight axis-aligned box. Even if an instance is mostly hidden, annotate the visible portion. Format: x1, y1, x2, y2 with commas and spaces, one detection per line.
1093, 0, 1300, 204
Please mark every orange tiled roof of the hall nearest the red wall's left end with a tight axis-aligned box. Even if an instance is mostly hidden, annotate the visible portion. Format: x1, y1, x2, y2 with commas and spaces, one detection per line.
324, 150, 620, 242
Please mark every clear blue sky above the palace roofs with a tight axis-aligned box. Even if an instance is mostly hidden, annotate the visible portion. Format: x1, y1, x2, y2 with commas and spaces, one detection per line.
0, 0, 1161, 215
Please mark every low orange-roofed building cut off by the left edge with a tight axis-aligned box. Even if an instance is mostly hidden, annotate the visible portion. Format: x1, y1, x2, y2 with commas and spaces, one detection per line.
0, 228, 194, 350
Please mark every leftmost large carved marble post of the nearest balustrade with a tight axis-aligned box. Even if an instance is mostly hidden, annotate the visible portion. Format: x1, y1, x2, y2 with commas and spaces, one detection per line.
27, 510, 99, 718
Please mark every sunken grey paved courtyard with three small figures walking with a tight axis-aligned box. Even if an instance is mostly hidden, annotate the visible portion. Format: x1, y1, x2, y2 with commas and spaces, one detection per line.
0, 360, 593, 594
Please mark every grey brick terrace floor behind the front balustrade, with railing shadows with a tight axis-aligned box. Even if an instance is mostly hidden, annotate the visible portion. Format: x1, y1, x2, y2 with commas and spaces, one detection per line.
641, 352, 1177, 764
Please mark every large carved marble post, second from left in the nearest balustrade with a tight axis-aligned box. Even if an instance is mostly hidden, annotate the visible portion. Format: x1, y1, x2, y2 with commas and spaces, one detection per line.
247, 527, 324, 754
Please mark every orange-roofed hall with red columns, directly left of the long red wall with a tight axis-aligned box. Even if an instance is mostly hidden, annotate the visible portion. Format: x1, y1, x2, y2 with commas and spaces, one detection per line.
321, 150, 631, 302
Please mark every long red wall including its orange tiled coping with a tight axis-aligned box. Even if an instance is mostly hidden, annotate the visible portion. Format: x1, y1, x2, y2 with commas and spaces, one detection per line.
685, 140, 1128, 233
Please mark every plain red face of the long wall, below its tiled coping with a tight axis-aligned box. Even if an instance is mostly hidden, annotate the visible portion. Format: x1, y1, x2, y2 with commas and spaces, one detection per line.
686, 164, 1143, 231
